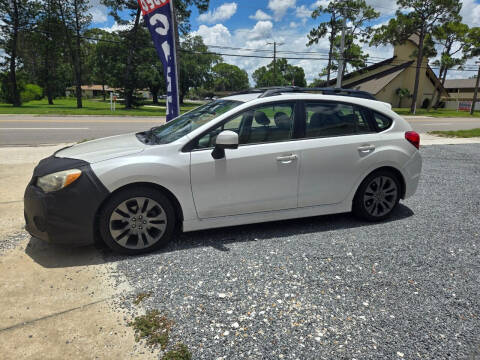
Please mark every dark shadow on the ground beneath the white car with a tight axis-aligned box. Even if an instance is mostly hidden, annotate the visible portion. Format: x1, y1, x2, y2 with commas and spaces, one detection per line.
25, 204, 414, 268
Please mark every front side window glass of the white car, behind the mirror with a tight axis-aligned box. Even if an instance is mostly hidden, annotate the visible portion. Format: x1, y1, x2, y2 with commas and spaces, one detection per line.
195, 102, 295, 149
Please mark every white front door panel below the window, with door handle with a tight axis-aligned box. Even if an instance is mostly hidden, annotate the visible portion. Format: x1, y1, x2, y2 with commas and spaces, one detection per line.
190, 141, 299, 218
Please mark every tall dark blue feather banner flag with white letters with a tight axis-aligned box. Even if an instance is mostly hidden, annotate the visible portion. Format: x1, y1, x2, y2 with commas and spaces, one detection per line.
138, 0, 180, 121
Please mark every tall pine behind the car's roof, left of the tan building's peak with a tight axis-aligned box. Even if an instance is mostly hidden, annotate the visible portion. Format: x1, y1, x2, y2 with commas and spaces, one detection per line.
307, 0, 380, 83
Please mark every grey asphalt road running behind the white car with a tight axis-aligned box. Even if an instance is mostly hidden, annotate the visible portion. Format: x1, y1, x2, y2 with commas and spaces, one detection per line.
0, 115, 480, 146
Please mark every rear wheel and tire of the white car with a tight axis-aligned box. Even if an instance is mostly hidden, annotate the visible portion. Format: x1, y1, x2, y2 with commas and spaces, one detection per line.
352, 170, 401, 221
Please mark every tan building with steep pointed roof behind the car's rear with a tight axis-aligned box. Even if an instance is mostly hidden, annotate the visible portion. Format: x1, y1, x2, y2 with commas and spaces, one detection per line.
328, 35, 448, 108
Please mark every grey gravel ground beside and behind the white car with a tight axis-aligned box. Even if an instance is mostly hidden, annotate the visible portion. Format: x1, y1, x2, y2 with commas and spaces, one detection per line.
106, 144, 480, 359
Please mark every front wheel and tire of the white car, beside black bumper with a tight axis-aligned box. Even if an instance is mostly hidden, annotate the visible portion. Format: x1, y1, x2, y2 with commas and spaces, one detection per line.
99, 186, 177, 255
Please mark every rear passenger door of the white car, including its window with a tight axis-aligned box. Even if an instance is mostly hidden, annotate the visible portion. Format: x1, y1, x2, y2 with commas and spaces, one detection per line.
298, 101, 379, 207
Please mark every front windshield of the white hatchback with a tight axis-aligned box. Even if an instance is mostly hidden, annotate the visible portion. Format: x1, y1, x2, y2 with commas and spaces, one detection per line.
150, 100, 242, 144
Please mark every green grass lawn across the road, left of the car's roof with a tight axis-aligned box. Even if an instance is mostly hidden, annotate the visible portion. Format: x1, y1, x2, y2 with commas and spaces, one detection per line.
0, 98, 199, 116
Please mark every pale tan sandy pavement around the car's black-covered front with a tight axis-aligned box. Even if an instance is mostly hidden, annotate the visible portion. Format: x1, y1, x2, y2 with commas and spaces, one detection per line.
0, 146, 156, 359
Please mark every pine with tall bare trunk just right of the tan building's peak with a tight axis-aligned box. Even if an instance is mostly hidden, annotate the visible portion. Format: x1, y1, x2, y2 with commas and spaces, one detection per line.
371, 0, 462, 114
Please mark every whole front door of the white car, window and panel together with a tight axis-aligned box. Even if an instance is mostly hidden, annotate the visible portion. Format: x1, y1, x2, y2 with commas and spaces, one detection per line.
190, 102, 299, 219
